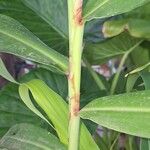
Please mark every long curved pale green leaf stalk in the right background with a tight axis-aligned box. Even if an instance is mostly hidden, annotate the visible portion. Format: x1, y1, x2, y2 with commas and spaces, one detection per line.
110, 40, 143, 95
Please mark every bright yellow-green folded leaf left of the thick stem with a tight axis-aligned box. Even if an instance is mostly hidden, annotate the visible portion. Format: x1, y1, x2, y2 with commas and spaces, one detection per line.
19, 79, 68, 144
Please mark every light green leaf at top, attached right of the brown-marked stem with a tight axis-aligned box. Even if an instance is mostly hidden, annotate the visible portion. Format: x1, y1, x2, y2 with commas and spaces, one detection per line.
83, 0, 150, 21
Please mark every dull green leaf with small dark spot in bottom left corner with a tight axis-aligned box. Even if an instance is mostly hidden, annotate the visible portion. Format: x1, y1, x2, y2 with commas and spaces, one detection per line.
0, 124, 67, 150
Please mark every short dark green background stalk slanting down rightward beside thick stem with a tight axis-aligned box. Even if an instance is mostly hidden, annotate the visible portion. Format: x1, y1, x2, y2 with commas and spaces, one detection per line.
83, 57, 106, 90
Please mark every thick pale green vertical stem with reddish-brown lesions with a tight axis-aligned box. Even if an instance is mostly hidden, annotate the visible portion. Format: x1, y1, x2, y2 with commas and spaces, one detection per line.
68, 0, 84, 150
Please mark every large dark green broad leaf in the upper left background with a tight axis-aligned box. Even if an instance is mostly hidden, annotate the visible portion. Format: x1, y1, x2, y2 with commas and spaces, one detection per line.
0, 0, 68, 55
